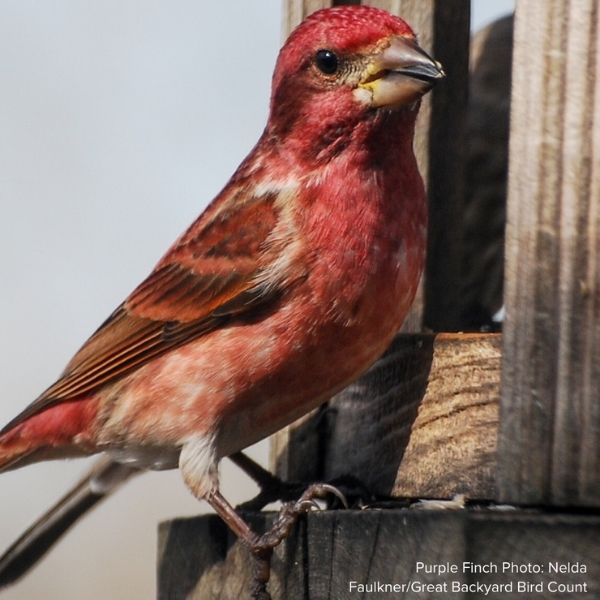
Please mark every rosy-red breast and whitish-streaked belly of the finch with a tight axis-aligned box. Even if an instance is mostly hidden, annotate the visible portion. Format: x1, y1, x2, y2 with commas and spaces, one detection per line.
92, 161, 425, 456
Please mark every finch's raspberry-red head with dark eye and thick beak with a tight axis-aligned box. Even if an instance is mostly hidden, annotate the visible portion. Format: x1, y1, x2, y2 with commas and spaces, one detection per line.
271, 6, 444, 148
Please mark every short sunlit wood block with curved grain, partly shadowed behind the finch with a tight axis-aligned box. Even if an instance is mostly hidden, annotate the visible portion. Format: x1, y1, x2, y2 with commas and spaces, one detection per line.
274, 334, 501, 498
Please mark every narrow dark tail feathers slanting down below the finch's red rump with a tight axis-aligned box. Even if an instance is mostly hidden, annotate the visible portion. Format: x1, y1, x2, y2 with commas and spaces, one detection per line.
0, 458, 139, 588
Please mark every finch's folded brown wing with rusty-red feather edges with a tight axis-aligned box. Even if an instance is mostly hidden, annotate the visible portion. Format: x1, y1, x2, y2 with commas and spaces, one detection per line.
0, 191, 304, 433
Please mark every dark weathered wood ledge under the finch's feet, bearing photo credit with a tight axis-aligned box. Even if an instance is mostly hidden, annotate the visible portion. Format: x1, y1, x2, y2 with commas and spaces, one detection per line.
158, 509, 600, 600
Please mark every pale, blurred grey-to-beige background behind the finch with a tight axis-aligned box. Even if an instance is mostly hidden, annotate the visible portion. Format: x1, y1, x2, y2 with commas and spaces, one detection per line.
0, 0, 514, 600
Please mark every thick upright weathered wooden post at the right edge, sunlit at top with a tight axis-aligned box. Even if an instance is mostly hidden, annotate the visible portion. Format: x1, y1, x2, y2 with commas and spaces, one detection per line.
499, 0, 600, 506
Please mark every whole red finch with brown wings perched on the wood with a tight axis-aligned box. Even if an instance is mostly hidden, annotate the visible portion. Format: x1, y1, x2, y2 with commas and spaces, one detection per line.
0, 6, 445, 598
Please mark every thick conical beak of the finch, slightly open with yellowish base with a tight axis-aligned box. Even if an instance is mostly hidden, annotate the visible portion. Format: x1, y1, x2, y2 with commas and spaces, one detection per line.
356, 36, 446, 107
